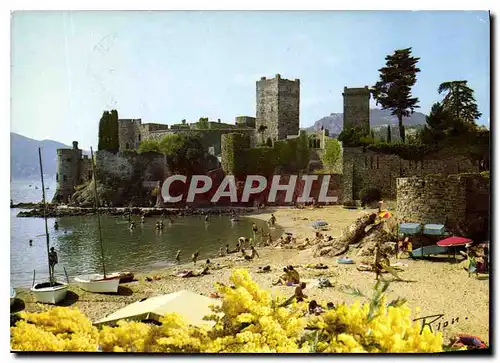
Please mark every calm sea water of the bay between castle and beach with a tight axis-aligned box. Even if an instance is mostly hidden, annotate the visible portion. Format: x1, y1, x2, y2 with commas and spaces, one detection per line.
10, 181, 279, 287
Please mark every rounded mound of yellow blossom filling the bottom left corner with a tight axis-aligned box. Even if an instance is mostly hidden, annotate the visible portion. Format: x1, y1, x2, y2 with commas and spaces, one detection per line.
10, 307, 99, 352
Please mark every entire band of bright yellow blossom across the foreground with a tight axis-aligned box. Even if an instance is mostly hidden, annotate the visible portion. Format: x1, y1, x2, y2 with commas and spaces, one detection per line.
11, 270, 443, 353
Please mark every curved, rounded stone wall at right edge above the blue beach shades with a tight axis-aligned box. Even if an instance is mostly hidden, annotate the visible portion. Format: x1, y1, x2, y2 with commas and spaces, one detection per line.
397, 174, 489, 240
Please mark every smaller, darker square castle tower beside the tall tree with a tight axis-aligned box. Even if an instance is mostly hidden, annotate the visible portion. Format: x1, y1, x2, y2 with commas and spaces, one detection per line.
342, 86, 370, 134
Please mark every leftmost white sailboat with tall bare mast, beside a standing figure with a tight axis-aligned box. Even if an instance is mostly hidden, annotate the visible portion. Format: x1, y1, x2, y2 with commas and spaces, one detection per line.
30, 148, 68, 304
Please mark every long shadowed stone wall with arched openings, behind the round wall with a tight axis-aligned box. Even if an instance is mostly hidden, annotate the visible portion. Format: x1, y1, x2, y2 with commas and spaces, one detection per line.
343, 147, 479, 203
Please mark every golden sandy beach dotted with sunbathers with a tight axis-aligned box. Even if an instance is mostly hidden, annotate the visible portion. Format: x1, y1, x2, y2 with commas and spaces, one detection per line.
14, 206, 489, 342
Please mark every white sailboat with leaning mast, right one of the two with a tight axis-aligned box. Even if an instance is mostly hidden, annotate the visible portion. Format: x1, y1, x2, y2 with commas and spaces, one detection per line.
75, 148, 121, 293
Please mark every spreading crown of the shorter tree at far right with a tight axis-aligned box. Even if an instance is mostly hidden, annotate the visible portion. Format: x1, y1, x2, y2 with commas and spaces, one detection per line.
438, 81, 481, 125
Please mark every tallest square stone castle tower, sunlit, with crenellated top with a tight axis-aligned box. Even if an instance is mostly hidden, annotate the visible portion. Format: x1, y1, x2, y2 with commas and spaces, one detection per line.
255, 74, 300, 142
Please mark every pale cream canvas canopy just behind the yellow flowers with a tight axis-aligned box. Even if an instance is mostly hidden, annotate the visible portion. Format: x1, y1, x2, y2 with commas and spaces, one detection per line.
95, 290, 221, 326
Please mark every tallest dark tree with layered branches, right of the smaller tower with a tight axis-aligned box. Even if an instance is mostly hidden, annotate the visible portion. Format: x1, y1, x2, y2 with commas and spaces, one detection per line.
372, 48, 420, 143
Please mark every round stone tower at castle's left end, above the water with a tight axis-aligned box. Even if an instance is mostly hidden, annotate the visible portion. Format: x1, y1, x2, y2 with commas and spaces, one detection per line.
53, 141, 84, 203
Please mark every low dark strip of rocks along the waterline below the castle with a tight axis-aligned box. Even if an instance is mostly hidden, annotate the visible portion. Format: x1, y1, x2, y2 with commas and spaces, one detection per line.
13, 203, 257, 218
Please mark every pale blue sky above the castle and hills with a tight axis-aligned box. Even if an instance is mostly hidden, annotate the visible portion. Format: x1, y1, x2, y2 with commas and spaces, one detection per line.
11, 11, 490, 149
